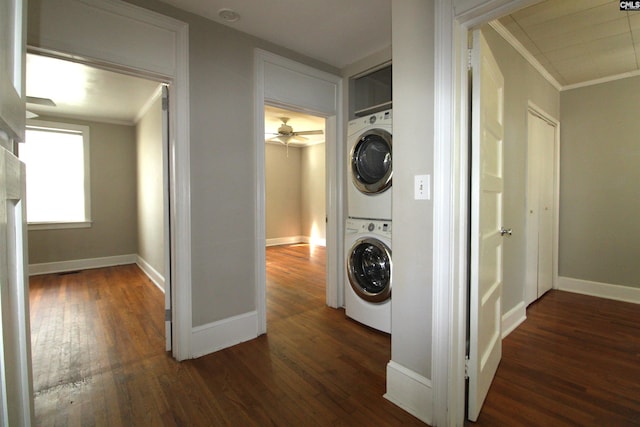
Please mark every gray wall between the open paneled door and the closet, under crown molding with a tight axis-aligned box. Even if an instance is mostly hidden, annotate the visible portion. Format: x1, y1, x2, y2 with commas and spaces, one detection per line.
482, 25, 560, 314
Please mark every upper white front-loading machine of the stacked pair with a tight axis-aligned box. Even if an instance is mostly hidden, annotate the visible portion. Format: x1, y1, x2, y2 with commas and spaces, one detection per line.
347, 110, 393, 220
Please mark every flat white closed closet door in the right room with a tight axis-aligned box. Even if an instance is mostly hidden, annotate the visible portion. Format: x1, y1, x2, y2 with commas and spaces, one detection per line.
525, 110, 556, 305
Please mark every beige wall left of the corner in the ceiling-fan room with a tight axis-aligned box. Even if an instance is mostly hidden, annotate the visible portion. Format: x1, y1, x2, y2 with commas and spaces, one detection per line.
265, 144, 302, 242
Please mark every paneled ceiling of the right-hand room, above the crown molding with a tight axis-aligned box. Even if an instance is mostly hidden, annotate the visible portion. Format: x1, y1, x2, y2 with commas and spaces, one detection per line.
499, 0, 640, 87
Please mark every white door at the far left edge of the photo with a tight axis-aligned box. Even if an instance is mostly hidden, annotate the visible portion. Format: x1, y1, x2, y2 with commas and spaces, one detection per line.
0, 0, 34, 426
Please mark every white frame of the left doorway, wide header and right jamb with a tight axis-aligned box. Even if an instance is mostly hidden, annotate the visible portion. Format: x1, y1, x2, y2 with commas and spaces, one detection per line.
28, 0, 192, 360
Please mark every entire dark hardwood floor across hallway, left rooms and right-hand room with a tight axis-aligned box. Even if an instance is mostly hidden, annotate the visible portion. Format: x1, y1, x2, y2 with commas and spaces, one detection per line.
30, 245, 640, 427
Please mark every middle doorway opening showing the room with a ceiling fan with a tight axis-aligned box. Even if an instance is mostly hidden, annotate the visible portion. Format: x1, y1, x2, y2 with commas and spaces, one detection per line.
264, 105, 326, 319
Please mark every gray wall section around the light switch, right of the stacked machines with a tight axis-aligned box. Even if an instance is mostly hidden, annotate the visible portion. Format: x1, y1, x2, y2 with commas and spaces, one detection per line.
391, 0, 434, 378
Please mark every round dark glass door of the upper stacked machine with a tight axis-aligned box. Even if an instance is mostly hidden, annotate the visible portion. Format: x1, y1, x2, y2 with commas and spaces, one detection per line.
351, 129, 393, 194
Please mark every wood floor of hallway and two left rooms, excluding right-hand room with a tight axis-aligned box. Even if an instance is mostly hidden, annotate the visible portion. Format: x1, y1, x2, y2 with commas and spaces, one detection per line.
30, 245, 424, 427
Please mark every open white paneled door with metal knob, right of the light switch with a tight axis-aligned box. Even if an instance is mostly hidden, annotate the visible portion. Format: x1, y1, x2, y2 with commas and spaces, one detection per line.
467, 30, 504, 421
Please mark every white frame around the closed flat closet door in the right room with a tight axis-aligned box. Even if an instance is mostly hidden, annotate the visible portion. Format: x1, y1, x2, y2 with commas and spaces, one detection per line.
524, 101, 560, 304
